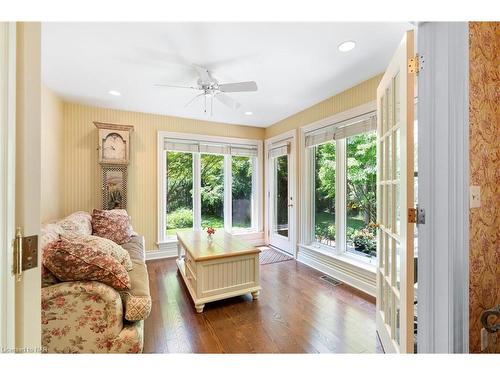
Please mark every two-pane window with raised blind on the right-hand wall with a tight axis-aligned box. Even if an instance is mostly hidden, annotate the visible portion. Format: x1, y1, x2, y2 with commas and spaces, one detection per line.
305, 113, 377, 263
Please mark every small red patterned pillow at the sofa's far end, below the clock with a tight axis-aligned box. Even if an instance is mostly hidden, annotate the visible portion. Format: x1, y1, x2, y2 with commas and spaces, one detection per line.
92, 210, 131, 245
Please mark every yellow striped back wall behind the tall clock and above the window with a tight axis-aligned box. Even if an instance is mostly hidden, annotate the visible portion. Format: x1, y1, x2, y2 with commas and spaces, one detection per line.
62, 103, 265, 251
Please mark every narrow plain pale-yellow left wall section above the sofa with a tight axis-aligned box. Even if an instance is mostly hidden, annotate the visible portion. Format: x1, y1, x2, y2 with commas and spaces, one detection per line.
40, 85, 64, 222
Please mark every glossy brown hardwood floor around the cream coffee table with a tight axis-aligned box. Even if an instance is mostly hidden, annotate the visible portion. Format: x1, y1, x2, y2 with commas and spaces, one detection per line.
144, 259, 383, 353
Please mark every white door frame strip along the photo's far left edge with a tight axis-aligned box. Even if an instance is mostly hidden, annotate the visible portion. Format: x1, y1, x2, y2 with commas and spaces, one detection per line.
0, 22, 16, 348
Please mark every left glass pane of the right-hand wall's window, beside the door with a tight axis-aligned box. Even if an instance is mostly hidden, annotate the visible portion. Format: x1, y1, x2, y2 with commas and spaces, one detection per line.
313, 142, 336, 246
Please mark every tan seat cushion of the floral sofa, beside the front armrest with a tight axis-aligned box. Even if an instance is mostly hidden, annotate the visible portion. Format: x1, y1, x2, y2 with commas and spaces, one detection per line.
120, 260, 151, 322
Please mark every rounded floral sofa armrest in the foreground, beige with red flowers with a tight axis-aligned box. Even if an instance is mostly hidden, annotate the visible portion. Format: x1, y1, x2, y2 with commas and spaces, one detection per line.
42, 281, 123, 353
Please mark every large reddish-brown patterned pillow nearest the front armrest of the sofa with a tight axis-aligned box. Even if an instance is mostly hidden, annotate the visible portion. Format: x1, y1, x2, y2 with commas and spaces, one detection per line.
42, 238, 131, 290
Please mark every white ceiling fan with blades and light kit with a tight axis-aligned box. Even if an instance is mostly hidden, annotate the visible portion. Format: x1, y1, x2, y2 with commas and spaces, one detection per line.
154, 64, 257, 115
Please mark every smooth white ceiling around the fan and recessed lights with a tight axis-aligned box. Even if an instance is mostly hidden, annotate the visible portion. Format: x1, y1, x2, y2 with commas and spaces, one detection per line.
42, 22, 412, 127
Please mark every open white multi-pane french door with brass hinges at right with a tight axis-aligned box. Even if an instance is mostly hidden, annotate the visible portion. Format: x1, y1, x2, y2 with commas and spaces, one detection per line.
376, 31, 415, 353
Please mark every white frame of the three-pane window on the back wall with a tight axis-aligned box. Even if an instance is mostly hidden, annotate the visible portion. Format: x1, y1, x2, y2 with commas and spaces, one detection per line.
157, 131, 263, 250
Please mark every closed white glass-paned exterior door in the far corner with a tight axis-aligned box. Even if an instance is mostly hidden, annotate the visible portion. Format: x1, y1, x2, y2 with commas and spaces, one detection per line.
268, 132, 295, 255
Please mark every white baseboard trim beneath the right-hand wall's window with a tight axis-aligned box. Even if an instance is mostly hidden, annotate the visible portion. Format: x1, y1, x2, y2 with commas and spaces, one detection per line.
297, 246, 377, 297
